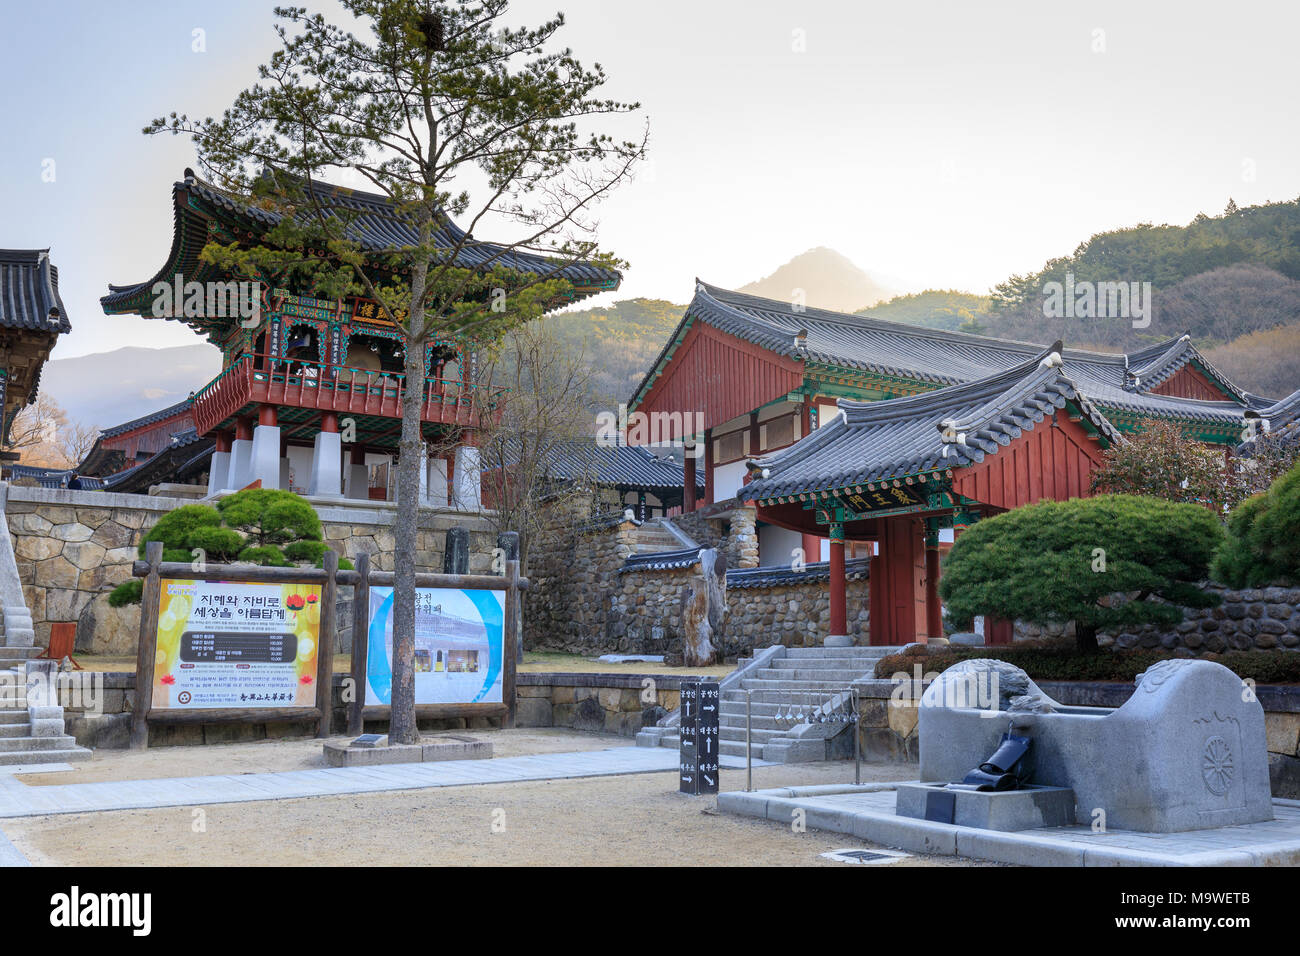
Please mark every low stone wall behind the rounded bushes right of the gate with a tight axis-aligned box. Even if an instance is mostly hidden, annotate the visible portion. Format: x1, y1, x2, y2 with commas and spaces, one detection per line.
1015, 584, 1300, 657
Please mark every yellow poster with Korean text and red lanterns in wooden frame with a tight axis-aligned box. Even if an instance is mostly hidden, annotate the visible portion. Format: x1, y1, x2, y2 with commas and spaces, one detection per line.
152, 579, 321, 709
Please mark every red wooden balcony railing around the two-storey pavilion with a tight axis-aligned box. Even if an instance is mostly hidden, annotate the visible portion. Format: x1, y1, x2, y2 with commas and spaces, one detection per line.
194, 355, 504, 434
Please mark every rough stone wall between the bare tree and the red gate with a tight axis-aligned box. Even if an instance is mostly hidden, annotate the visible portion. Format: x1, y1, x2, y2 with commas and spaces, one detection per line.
524, 496, 868, 662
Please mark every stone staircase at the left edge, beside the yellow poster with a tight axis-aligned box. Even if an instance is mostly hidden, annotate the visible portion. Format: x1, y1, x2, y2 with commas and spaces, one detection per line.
0, 608, 91, 766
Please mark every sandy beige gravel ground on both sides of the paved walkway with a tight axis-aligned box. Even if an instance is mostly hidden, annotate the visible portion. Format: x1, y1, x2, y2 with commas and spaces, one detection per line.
3, 730, 993, 866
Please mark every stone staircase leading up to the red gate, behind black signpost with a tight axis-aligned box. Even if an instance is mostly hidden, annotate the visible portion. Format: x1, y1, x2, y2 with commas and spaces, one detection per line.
637, 646, 898, 763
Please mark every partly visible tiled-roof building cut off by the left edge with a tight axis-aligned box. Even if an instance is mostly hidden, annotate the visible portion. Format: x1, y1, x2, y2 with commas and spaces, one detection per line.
0, 248, 72, 444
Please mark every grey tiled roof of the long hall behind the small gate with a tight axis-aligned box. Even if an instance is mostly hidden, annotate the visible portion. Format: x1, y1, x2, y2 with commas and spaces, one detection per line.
633, 280, 1248, 424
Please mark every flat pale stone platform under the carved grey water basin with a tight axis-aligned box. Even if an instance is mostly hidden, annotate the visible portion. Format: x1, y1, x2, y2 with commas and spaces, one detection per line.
718, 780, 1300, 866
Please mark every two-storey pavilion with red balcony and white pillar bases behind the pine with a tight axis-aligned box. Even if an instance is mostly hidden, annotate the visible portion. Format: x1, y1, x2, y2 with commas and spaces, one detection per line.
100, 169, 620, 510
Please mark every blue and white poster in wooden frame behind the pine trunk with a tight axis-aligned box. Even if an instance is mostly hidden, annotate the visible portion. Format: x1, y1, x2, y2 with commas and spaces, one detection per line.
365, 587, 506, 705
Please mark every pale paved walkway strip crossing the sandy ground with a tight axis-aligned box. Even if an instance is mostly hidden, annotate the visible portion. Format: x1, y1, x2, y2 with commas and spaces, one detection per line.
0, 747, 767, 816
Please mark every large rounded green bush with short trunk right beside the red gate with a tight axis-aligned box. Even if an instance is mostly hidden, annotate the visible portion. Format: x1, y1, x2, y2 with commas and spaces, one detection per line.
939, 494, 1223, 652
